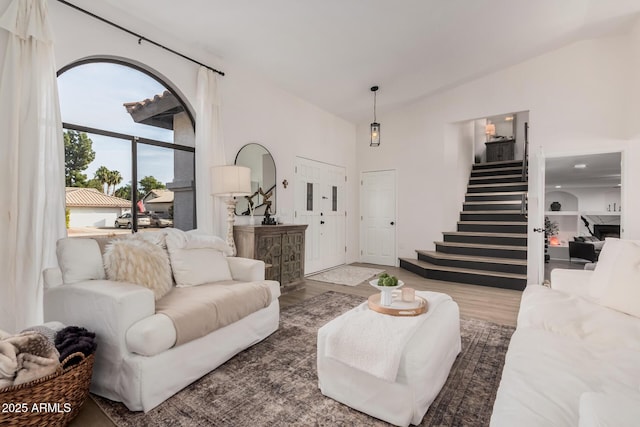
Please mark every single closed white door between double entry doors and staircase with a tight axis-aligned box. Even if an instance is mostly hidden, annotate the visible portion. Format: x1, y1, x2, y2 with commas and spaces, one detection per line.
360, 170, 397, 266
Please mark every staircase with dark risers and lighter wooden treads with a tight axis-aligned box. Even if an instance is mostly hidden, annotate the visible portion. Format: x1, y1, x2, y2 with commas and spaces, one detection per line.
400, 161, 527, 290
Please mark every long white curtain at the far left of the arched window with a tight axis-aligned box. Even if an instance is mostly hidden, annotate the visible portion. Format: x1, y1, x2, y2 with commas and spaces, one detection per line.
0, 0, 66, 332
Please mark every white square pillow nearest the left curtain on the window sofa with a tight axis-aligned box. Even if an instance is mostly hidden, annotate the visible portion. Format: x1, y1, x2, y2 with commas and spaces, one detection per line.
56, 237, 106, 284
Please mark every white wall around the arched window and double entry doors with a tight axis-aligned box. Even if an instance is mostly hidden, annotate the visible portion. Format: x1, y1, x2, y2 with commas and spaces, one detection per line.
0, 0, 359, 262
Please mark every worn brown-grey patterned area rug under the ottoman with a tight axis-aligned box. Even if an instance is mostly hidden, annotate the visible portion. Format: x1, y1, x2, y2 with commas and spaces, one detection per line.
93, 292, 514, 427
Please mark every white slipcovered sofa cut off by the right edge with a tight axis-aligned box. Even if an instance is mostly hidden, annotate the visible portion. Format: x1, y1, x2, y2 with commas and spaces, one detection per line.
491, 239, 640, 427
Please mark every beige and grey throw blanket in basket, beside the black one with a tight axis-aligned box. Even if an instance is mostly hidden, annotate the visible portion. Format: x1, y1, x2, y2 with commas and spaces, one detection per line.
0, 331, 60, 389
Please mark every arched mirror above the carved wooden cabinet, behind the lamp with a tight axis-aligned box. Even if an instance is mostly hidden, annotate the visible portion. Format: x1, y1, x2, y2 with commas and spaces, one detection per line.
235, 143, 276, 215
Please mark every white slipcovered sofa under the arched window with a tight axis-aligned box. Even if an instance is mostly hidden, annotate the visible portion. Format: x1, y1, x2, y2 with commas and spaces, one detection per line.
44, 232, 280, 412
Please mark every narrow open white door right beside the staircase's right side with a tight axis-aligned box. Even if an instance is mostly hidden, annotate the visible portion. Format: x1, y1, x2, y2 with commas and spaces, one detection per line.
527, 147, 545, 284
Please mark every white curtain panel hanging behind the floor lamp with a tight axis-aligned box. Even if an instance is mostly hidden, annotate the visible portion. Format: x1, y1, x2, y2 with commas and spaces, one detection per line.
196, 67, 227, 236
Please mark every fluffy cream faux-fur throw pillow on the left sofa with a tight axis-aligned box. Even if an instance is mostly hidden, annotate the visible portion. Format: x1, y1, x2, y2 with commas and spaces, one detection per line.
104, 238, 173, 300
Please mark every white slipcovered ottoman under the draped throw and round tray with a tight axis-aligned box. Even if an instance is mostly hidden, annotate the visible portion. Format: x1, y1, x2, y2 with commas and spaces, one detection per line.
318, 292, 461, 426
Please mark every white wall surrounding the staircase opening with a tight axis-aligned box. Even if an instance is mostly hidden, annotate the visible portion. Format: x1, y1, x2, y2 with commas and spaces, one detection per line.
356, 22, 640, 257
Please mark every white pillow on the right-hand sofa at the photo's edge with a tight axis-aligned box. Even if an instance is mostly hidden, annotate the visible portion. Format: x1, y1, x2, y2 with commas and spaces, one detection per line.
594, 240, 640, 317
